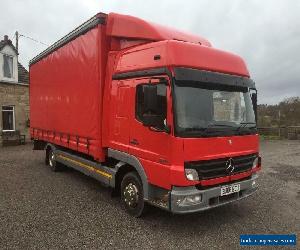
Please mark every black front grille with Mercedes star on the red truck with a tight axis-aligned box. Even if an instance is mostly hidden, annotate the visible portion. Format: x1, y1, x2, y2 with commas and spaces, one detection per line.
185, 154, 258, 180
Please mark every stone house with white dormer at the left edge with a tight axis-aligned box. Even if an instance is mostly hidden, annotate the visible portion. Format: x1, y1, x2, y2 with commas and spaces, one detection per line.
0, 36, 29, 145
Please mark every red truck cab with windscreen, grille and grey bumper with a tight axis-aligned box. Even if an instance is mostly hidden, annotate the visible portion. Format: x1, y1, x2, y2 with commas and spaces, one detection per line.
104, 40, 260, 213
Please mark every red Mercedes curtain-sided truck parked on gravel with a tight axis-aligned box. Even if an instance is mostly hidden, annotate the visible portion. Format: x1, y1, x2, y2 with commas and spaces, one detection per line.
30, 13, 261, 217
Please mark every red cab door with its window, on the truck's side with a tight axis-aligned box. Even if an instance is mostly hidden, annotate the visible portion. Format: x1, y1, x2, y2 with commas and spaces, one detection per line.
129, 78, 170, 186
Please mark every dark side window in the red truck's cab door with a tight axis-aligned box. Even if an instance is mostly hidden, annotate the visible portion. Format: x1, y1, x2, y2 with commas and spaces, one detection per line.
135, 84, 167, 127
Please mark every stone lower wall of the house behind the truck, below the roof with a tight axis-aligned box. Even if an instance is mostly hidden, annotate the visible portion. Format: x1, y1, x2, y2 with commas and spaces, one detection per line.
0, 82, 30, 145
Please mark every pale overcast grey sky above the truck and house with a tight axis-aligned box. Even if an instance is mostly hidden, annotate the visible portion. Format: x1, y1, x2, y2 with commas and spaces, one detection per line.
0, 0, 300, 103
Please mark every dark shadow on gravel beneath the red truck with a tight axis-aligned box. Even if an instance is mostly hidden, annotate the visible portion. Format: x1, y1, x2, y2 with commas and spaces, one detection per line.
64, 165, 253, 233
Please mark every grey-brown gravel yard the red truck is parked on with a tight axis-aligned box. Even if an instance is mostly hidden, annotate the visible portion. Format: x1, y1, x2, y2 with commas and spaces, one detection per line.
0, 141, 300, 249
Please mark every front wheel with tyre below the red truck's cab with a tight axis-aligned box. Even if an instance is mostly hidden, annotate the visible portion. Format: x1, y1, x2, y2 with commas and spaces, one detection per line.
121, 172, 145, 217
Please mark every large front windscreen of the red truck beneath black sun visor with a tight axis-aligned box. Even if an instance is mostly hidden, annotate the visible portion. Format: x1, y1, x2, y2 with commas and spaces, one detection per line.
174, 81, 256, 136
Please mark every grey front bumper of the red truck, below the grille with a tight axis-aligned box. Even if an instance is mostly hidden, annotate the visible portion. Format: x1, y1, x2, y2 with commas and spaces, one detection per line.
170, 174, 257, 213
